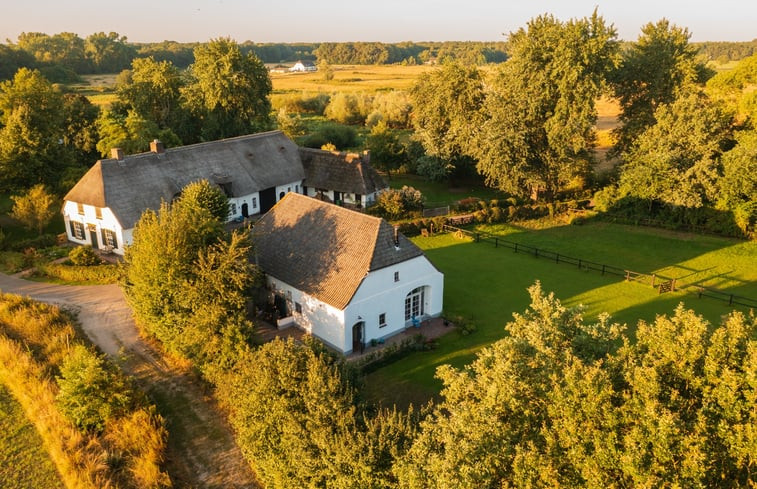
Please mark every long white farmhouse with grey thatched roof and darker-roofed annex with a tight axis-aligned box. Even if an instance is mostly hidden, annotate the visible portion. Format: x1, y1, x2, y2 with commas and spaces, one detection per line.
63, 131, 386, 255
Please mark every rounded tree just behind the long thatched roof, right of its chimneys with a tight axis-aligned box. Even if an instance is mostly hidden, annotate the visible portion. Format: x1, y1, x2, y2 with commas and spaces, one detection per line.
184, 38, 272, 140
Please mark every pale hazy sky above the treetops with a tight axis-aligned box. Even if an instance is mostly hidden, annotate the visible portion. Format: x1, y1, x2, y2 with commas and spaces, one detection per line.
0, 0, 757, 42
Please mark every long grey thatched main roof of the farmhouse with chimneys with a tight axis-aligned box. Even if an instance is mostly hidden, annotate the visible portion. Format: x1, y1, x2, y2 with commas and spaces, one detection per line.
65, 131, 305, 229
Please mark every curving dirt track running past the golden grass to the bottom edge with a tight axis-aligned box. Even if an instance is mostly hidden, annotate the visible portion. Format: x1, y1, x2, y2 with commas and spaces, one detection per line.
0, 274, 259, 489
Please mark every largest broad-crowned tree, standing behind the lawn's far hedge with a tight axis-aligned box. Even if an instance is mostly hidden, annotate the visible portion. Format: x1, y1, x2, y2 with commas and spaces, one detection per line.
476, 11, 618, 199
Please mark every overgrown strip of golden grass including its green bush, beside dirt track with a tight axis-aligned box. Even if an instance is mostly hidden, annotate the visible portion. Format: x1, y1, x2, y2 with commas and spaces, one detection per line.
0, 295, 171, 489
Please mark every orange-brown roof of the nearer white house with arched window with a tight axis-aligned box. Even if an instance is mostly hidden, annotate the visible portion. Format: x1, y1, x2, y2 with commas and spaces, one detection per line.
252, 193, 423, 309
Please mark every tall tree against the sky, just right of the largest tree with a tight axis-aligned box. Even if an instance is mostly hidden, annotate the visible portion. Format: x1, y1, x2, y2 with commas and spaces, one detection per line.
612, 19, 704, 153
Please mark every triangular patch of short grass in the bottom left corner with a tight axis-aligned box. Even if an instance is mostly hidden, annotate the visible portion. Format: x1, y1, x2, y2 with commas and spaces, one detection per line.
0, 386, 64, 489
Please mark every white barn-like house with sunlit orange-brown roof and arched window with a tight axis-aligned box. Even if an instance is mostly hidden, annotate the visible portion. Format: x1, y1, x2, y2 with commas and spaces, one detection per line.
253, 193, 444, 353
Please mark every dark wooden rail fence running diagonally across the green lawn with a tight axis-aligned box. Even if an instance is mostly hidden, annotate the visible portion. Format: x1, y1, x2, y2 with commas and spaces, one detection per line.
442, 224, 757, 308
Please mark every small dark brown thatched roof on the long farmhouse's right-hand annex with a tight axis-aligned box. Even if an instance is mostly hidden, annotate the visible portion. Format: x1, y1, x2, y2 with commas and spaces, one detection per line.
300, 148, 387, 195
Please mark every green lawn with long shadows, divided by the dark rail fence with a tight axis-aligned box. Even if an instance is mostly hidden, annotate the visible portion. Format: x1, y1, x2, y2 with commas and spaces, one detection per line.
366, 223, 757, 405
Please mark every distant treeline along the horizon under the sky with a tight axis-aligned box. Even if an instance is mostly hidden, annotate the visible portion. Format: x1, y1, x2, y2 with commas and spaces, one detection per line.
0, 32, 757, 83
